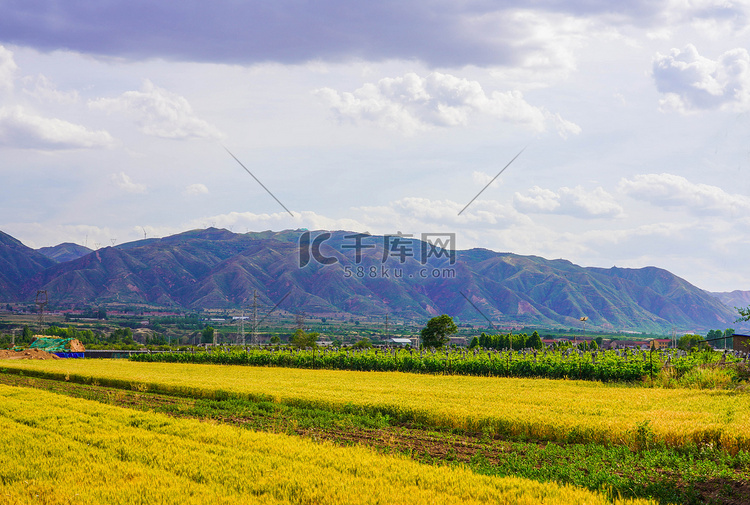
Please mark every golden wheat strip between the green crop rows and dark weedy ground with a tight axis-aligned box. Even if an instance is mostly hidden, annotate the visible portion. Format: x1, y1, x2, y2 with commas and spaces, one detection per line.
2, 360, 750, 451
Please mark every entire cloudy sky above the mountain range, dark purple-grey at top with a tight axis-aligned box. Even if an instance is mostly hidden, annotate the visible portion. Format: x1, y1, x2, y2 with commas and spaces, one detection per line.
0, 0, 750, 291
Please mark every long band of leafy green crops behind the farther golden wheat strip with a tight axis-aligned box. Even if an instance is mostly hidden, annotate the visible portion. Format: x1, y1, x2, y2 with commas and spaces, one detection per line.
131, 348, 740, 382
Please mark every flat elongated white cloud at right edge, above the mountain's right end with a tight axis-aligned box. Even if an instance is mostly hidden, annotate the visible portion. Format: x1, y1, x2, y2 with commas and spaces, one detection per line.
619, 173, 750, 214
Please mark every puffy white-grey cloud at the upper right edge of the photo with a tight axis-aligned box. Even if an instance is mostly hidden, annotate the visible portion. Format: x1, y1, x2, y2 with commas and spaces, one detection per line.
653, 44, 750, 112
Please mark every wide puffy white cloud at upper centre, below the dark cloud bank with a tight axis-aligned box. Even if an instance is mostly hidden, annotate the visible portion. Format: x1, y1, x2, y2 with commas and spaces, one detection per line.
315, 72, 580, 136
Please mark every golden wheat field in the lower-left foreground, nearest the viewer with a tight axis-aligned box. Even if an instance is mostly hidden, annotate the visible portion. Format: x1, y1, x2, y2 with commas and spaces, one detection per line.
0, 386, 648, 505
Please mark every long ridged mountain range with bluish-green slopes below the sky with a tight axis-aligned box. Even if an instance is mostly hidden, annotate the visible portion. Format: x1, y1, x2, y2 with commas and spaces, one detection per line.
0, 228, 746, 331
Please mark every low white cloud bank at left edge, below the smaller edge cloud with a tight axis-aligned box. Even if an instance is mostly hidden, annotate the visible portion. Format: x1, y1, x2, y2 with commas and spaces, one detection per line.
0, 106, 113, 150
